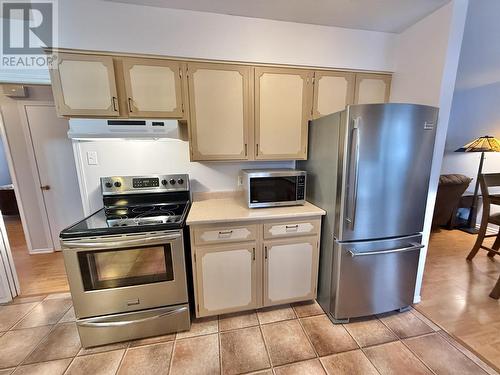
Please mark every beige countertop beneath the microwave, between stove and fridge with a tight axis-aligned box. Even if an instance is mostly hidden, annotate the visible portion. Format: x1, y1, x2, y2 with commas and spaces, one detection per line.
186, 197, 326, 225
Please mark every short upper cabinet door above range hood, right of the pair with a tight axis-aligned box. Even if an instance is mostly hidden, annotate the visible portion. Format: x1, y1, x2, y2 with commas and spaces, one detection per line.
123, 58, 183, 118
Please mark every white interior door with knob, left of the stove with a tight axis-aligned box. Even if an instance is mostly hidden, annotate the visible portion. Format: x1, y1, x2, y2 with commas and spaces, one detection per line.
20, 103, 83, 250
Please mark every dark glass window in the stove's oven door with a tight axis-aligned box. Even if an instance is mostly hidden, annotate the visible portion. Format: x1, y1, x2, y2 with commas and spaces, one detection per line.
78, 244, 174, 291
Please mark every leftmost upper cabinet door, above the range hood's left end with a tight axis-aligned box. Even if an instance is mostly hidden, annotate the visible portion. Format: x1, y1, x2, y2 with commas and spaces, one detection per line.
50, 53, 119, 116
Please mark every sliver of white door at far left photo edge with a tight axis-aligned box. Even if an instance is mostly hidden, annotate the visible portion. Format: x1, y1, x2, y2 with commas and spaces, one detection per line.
0, 212, 19, 303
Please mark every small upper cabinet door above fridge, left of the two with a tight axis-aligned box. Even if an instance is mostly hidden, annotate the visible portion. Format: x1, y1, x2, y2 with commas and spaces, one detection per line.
313, 71, 354, 119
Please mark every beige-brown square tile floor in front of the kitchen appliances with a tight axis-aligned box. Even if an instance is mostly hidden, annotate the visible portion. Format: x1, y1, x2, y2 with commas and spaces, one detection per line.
0, 293, 496, 375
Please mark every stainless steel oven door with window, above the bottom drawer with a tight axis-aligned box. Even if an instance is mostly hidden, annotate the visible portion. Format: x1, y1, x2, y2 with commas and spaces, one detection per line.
61, 231, 188, 318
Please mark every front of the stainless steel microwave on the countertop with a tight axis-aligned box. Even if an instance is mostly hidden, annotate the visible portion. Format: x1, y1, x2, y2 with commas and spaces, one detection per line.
248, 176, 304, 208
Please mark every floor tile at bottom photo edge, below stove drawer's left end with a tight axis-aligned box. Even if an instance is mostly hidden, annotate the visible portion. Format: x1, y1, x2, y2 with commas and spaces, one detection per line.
65, 349, 125, 375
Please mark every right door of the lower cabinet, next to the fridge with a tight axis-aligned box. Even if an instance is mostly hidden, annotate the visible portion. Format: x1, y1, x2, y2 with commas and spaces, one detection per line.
264, 237, 318, 305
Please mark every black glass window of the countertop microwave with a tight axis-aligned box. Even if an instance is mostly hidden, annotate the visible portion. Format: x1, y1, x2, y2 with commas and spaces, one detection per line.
250, 177, 297, 203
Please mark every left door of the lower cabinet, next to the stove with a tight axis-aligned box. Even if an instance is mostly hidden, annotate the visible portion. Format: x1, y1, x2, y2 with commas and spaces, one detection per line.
195, 244, 257, 316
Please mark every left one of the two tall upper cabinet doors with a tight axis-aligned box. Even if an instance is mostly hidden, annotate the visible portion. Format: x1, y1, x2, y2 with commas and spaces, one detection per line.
188, 63, 251, 160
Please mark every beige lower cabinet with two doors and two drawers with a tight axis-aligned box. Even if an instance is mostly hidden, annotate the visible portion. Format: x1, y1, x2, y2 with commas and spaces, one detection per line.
191, 217, 320, 317
